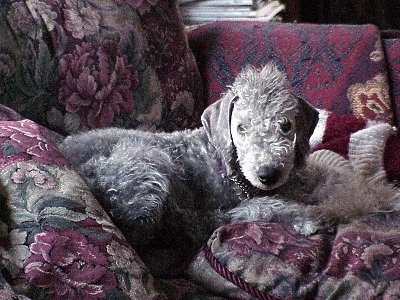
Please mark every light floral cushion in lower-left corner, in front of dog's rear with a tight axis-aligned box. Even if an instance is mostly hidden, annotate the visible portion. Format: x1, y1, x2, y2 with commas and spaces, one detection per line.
0, 120, 163, 299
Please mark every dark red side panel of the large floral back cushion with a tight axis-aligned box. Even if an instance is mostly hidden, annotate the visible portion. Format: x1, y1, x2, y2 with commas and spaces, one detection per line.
140, 1, 204, 130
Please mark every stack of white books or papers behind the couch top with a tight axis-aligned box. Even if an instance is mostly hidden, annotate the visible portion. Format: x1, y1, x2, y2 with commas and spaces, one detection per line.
179, 0, 285, 24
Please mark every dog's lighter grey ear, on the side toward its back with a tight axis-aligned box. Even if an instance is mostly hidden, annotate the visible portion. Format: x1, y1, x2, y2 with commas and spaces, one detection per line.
201, 90, 236, 171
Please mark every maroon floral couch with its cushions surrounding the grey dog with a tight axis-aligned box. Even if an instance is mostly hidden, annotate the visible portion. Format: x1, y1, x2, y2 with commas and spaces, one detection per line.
0, 0, 400, 299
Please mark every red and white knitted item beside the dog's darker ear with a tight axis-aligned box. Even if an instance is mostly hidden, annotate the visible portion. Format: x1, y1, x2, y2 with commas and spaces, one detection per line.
310, 110, 400, 181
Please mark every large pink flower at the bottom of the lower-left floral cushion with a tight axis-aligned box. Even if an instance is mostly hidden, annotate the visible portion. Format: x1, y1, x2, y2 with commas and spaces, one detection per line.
25, 228, 116, 299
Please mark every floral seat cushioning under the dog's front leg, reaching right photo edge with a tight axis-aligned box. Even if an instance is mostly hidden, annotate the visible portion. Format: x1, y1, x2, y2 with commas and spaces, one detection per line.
189, 217, 400, 300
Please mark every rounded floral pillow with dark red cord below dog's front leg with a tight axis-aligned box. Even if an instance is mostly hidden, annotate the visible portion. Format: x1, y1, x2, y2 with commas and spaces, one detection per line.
188, 222, 326, 299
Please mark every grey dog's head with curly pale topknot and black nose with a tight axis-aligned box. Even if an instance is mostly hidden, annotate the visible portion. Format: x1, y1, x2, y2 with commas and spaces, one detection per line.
202, 64, 318, 190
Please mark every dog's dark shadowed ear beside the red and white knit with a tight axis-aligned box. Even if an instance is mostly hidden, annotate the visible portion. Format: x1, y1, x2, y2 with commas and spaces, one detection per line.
295, 97, 319, 167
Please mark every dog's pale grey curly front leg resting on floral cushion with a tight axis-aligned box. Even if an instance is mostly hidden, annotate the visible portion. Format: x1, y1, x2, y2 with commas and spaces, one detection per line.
228, 197, 321, 235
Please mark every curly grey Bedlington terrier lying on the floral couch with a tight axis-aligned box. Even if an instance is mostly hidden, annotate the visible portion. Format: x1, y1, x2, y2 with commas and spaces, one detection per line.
60, 64, 400, 276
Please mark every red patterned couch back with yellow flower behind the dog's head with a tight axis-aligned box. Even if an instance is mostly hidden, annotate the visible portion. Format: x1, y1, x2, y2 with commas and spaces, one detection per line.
189, 21, 392, 121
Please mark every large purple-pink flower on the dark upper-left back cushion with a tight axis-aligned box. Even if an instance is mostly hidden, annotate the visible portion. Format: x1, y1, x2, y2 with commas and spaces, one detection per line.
59, 40, 138, 128
